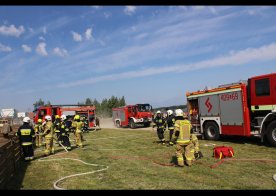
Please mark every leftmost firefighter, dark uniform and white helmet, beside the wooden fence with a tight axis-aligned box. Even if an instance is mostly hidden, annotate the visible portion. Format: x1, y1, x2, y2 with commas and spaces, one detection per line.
16, 117, 35, 161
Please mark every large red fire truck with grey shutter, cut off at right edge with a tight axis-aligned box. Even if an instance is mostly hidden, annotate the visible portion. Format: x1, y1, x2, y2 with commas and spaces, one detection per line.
186, 73, 276, 146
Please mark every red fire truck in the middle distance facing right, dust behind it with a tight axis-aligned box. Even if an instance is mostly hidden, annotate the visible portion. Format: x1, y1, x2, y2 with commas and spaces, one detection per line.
112, 104, 152, 129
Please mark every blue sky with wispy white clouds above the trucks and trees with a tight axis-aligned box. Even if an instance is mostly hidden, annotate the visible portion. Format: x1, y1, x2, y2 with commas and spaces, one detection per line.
0, 6, 276, 111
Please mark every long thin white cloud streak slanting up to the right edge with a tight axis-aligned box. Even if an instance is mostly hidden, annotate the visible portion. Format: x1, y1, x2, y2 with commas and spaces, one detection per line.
57, 43, 276, 88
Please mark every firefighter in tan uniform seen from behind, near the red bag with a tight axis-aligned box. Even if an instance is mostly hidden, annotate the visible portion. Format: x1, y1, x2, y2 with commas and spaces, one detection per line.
174, 109, 195, 167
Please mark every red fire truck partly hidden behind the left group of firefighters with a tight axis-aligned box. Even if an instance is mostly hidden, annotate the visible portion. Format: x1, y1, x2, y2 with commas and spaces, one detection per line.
33, 105, 96, 128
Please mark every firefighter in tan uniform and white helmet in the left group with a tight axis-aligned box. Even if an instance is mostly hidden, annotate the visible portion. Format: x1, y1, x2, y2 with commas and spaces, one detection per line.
43, 115, 55, 156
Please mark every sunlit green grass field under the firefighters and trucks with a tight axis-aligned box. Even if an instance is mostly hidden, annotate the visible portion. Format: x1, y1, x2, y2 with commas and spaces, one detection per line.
7, 129, 276, 190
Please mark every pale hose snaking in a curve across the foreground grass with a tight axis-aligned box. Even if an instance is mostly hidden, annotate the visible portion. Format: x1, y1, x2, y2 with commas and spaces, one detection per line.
38, 152, 109, 190
